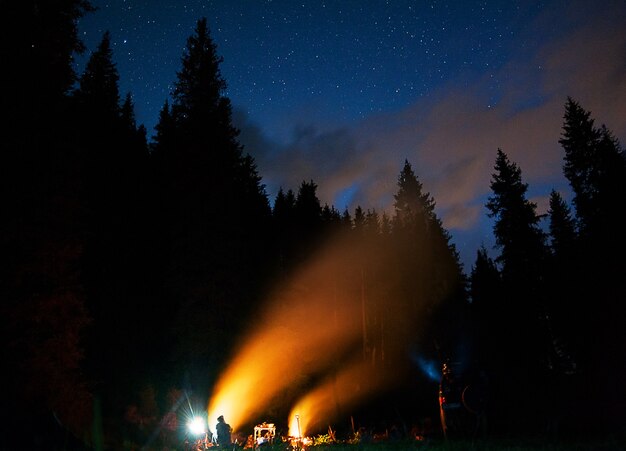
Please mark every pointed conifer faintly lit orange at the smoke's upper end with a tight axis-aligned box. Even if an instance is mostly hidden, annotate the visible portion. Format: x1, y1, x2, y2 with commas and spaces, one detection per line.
392, 160, 465, 370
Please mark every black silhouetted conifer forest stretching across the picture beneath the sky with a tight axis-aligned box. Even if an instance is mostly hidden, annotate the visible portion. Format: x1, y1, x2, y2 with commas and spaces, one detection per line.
0, 0, 626, 449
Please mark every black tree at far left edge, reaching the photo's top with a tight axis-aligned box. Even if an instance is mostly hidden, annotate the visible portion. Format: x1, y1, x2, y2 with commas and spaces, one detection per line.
0, 0, 92, 449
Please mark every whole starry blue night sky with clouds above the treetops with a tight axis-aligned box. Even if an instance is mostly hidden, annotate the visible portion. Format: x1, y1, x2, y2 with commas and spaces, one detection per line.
76, 0, 626, 271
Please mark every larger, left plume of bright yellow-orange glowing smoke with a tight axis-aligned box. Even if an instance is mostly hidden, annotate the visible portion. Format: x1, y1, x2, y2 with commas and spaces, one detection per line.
208, 237, 360, 429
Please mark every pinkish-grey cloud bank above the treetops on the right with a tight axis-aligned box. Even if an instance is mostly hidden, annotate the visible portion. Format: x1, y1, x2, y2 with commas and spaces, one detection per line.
232, 1, 626, 264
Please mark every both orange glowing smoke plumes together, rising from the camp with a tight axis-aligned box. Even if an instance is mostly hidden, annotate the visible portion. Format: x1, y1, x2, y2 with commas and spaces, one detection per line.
208, 224, 454, 435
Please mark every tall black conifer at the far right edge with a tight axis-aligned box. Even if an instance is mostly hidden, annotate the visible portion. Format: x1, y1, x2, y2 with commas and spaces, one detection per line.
559, 98, 626, 427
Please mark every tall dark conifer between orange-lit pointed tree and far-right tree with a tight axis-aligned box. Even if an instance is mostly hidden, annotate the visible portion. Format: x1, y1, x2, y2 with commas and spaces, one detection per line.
487, 149, 547, 426
